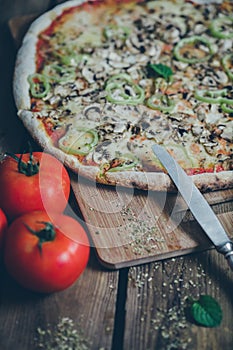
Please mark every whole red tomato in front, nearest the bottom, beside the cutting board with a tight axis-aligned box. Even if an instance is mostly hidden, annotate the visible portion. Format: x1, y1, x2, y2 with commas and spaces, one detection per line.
4, 211, 90, 293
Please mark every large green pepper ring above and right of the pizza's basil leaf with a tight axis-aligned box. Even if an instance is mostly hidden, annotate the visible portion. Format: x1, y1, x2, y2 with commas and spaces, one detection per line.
173, 35, 214, 64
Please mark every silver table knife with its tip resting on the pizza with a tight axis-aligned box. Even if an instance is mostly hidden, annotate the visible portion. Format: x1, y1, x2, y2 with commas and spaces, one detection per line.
152, 144, 233, 270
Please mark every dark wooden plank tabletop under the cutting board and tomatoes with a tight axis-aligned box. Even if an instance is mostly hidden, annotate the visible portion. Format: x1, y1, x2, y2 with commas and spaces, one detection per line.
0, 0, 233, 350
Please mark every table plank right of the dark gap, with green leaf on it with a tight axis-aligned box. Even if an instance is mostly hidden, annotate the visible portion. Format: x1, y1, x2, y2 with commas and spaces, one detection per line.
123, 251, 233, 350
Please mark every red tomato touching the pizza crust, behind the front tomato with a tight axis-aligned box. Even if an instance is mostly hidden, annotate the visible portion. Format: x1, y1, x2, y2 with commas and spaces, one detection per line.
0, 152, 70, 219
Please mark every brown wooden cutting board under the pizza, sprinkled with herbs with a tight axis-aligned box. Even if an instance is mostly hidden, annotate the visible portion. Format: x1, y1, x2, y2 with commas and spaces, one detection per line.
9, 15, 233, 269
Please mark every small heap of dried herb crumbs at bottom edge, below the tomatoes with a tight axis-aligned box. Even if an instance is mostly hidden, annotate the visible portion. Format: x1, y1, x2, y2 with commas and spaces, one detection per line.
36, 317, 89, 350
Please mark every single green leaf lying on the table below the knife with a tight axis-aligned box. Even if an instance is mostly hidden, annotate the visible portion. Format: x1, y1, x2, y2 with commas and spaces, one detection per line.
190, 295, 222, 327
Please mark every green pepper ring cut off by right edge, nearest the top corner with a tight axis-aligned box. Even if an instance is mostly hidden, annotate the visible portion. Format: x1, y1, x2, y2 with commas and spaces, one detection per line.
209, 16, 233, 39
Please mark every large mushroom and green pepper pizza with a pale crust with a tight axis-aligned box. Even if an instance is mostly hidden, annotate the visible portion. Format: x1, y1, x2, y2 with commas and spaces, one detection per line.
13, 0, 233, 191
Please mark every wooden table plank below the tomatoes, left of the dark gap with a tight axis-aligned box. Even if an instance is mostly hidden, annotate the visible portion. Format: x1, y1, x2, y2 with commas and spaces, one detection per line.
0, 255, 118, 350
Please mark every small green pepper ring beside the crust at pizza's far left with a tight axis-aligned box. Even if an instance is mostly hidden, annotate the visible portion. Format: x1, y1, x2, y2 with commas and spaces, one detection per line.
28, 73, 50, 98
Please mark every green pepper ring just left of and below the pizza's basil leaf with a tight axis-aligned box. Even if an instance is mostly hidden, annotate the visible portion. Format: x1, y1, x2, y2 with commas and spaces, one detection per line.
105, 74, 145, 105
